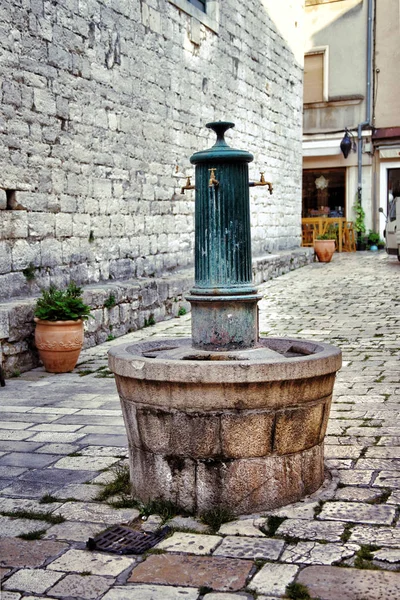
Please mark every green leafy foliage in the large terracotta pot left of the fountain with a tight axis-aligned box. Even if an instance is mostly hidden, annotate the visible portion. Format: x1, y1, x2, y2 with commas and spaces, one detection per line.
35, 282, 91, 321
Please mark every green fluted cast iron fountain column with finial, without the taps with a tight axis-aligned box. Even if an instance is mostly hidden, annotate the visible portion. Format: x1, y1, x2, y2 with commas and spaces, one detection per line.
187, 121, 261, 351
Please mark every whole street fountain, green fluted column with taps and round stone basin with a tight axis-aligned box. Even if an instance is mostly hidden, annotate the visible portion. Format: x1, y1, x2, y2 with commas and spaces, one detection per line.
109, 121, 341, 514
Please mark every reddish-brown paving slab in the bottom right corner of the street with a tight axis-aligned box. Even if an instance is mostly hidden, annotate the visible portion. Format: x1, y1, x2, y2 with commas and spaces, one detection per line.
297, 567, 400, 600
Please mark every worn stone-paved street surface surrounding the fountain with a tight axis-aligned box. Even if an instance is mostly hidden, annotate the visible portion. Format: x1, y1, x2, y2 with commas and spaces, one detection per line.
0, 253, 400, 600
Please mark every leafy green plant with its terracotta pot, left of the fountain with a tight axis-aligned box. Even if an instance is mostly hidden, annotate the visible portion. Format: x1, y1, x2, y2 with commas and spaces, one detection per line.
34, 282, 90, 373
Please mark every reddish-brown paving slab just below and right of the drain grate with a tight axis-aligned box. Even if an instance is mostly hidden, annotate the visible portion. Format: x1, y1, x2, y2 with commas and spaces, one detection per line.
128, 554, 253, 591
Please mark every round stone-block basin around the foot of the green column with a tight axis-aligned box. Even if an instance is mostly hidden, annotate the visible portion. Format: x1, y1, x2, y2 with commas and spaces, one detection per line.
109, 338, 341, 514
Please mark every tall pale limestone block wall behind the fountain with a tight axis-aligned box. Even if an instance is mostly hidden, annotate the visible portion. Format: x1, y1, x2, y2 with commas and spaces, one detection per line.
0, 0, 302, 300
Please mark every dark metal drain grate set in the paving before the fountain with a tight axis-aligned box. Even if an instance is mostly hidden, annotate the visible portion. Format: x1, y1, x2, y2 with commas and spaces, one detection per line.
86, 525, 170, 554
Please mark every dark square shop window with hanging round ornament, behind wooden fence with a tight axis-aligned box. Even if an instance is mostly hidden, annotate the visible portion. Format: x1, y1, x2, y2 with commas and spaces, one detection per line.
302, 169, 346, 218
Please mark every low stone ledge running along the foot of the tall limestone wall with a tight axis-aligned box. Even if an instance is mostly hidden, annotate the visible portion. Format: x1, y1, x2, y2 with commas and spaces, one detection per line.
0, 248, 314, 376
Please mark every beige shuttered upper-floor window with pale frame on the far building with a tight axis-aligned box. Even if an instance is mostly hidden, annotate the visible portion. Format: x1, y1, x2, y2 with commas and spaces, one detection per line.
303, 48, 328, 104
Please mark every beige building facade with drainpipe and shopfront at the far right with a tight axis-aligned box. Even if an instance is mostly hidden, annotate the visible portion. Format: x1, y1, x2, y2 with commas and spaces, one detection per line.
302, 0, 400, 236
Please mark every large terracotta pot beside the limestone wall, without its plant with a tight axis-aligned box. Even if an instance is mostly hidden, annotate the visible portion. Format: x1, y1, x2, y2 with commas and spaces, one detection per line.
35, 318, 83, 373
